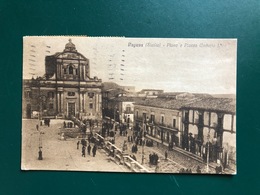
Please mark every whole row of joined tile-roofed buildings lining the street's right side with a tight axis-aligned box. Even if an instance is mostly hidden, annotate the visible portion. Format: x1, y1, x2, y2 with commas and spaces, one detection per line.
134, 93, 236, 170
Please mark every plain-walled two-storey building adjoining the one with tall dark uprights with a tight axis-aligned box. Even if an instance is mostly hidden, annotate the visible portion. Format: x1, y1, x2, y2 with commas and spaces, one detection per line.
134, 98, 186, 146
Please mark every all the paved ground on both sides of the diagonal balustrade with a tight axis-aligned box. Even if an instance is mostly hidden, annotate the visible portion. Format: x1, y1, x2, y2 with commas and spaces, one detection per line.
22, 119, 232, 173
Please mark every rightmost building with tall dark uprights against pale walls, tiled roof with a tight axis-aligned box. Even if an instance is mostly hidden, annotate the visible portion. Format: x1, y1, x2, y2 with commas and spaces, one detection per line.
181, 98, 236, 169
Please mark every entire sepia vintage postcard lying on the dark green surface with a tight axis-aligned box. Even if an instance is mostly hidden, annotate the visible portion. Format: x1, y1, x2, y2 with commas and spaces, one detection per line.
21, 36, 237, 174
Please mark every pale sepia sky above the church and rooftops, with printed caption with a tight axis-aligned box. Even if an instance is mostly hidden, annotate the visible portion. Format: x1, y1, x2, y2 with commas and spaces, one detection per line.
23, 36, 237, 94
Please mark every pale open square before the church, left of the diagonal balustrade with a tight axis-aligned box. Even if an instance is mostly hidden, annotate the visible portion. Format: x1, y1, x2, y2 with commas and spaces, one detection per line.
22, 119, 128, 172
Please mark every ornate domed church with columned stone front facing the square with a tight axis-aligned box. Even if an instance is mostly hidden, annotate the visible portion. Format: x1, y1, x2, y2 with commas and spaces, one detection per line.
23, 40, 102, 119
